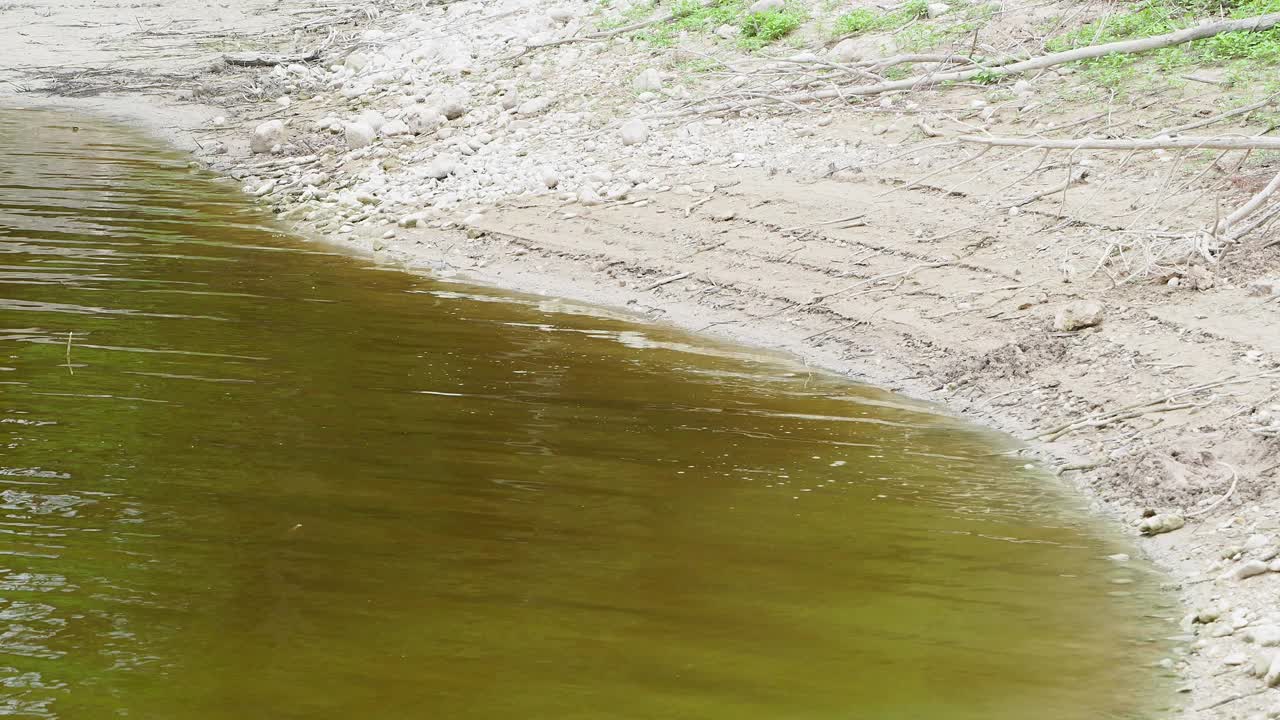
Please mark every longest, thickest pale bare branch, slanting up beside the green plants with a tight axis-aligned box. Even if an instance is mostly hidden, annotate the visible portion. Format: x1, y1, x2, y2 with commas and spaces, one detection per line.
653, 13, 1280, 118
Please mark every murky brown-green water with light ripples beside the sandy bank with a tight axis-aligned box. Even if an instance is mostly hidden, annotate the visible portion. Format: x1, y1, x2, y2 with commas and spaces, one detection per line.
0, 111, 1165, 720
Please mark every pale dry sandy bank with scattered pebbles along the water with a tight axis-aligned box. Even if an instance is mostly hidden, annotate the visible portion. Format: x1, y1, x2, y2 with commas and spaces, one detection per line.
0, 0, 1280, 717
